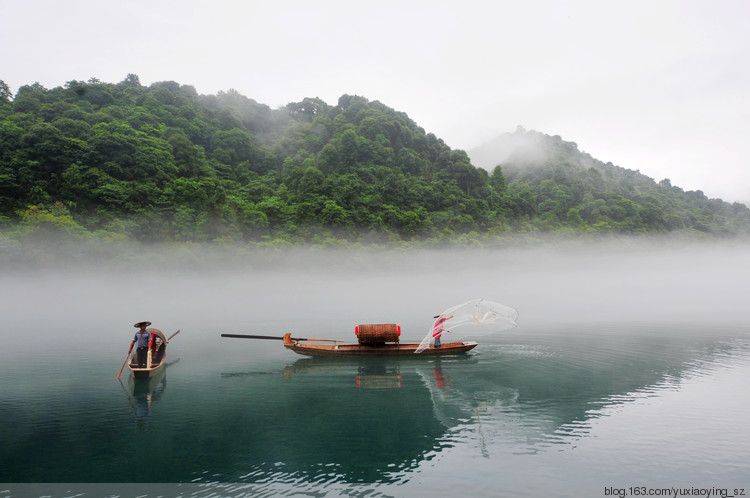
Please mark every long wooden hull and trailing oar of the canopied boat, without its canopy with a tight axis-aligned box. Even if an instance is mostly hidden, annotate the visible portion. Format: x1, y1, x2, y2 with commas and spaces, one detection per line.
221, 326, 477, 357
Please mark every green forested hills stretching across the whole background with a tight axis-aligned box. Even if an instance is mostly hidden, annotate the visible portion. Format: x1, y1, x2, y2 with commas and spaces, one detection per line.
0, 75, 750, 249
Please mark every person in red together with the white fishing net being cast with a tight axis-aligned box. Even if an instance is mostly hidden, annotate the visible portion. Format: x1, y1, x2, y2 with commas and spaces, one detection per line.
415, 299, 518, 353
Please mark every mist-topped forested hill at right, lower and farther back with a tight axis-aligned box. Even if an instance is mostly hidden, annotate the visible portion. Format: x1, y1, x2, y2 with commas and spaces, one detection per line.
469, 127, 750, 234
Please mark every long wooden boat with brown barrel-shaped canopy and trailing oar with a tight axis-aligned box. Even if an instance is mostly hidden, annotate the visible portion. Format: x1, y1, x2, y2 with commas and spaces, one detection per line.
221, 324, 477, 357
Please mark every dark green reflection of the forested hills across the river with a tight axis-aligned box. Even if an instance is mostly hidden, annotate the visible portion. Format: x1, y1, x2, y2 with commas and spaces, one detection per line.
0, 326, 750, 489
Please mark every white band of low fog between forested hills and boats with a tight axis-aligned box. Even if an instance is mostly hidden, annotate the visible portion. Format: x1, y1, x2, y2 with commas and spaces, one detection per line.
0, 240, 750, 354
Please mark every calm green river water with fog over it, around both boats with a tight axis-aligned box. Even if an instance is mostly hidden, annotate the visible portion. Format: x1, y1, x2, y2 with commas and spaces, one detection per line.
0, 239, 750, 497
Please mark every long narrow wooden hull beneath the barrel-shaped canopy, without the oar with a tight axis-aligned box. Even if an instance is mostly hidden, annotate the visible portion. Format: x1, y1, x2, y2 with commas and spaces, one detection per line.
284, 341, 477, 357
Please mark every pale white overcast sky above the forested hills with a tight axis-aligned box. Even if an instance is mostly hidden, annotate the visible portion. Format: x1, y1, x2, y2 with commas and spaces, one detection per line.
5, 0, 750, 202
